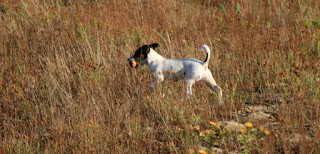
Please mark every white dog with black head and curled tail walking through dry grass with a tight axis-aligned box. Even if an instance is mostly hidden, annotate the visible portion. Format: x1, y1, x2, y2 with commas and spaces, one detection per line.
128, 43, 223, 104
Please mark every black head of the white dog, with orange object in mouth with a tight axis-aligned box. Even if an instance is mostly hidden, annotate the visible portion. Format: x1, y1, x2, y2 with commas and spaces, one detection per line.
128, 43, 159, 68
